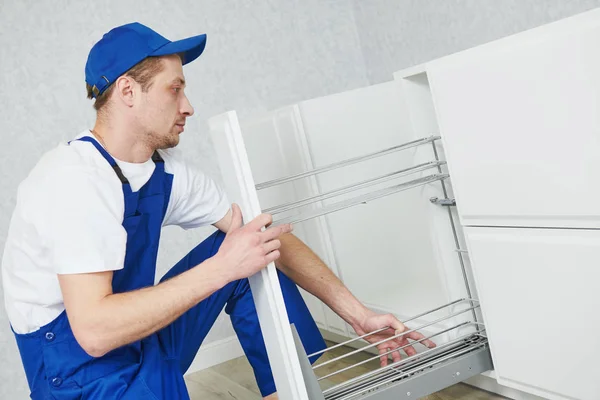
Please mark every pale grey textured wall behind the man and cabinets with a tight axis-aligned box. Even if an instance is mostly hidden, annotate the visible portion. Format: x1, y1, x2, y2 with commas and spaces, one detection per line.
0, 0, 600, 399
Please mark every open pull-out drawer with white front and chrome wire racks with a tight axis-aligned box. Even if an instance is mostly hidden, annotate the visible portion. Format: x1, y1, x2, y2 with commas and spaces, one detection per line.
211, 109, 493, 400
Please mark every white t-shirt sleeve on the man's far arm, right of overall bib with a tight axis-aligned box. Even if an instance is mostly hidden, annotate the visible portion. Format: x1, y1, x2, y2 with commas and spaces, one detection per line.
163, 153, 230, 229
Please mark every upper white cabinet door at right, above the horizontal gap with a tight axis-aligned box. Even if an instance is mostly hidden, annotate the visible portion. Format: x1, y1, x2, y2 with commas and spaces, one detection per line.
427, 10, 600, 228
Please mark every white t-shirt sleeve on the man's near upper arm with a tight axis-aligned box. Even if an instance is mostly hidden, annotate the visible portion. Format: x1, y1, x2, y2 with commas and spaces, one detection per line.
34, 168, 127, 274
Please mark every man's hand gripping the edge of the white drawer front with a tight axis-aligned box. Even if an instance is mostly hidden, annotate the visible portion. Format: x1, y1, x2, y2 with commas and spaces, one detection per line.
215, 204, 292, 281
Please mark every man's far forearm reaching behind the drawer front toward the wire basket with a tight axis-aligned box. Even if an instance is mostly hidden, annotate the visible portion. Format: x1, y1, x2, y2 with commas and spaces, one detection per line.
276, 234, 368, 326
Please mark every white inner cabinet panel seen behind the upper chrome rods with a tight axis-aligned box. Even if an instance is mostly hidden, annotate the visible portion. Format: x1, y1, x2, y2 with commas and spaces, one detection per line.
299, 82, 464, 324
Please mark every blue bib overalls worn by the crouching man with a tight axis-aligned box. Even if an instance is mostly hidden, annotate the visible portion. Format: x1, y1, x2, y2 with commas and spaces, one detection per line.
15, 137, 325, 400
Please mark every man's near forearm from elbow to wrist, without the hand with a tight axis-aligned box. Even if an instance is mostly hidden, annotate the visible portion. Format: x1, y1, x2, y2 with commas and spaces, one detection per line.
67, 259, 227, 357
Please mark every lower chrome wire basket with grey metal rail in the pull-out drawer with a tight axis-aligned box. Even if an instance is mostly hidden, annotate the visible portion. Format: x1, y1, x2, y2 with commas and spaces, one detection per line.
294, 299, 493, 400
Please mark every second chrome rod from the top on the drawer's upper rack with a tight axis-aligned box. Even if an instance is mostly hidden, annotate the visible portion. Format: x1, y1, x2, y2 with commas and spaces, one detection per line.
264, 161, 445, 214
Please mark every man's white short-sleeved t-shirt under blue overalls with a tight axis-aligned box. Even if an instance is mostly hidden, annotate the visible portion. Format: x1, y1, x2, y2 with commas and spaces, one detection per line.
2, 131, 230, 333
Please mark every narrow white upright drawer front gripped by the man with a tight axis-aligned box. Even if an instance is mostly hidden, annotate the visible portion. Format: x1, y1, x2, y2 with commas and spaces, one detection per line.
208, 111, 308, 400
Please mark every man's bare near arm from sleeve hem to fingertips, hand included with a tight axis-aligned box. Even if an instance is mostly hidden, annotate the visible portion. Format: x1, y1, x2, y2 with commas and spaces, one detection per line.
58, 204, 291, 356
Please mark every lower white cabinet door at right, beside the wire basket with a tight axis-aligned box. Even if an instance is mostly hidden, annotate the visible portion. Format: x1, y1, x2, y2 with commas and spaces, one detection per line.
465, 227, 600, 400
